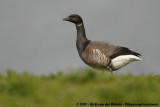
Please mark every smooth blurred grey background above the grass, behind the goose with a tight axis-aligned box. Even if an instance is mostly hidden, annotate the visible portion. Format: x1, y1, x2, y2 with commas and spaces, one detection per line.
0, 0, 160, 75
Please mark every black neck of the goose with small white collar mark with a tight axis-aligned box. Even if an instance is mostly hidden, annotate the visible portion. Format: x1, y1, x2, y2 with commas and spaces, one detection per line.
76, 22, 89, 56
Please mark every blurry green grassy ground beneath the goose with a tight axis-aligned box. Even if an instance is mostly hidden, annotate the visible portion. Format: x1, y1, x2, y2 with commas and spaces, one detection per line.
0, 69, 160, 107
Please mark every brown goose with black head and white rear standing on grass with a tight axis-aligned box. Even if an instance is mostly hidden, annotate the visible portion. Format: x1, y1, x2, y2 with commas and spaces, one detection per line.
63, 14, 142, 73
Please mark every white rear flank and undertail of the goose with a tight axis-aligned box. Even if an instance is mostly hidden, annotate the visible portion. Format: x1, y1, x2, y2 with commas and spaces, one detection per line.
112, 55, 142, 69
